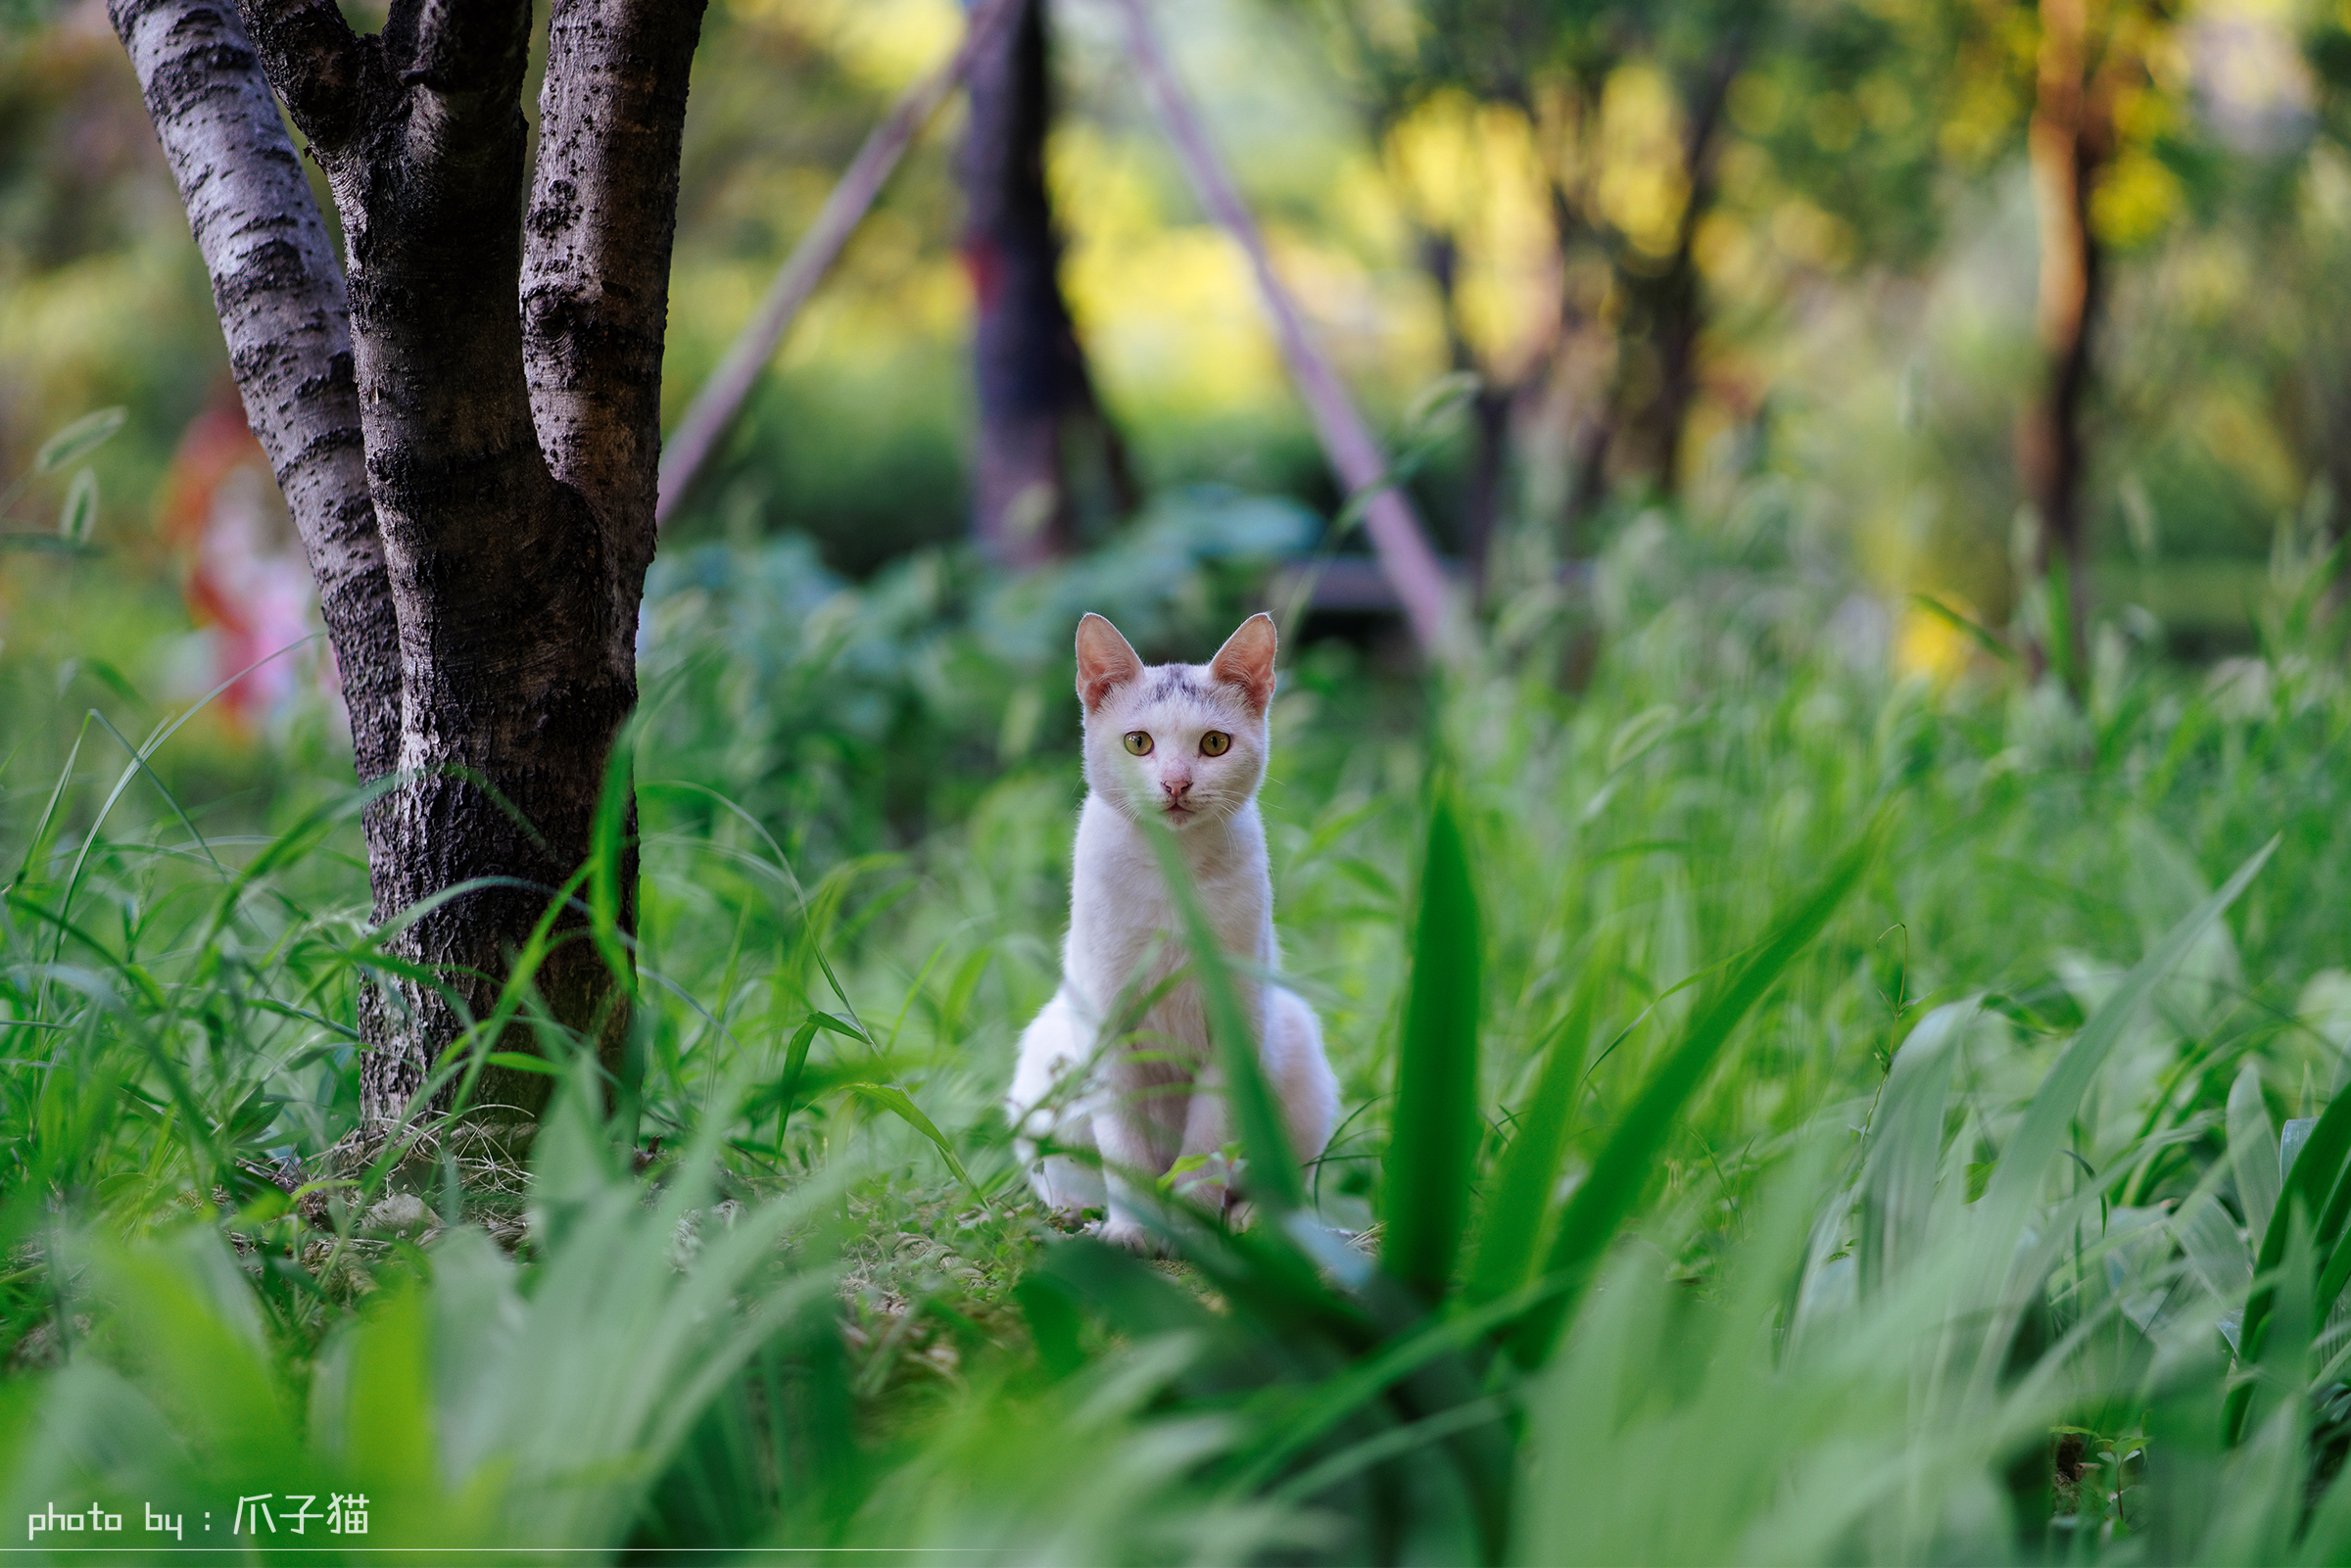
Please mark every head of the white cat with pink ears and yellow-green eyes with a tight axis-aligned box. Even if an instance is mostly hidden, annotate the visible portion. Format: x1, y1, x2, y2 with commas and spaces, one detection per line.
1077, 613, 1276, 830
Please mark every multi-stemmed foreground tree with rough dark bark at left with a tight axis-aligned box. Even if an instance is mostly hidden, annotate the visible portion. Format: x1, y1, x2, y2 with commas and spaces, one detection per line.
113, 0, 703, 1126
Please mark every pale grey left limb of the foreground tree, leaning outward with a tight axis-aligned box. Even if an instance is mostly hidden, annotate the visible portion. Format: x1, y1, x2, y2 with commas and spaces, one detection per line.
111, 0, 400, 783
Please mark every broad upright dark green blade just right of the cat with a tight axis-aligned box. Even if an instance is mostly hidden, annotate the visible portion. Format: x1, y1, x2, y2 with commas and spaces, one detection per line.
1380, 794, 1483, 1300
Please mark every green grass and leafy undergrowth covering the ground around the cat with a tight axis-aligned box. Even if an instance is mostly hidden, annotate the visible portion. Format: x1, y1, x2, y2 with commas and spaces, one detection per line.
0, 509, 2351, 1563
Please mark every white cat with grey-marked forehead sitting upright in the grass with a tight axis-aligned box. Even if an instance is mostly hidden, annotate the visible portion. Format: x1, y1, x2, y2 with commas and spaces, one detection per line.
1006, 613, 1338, 1251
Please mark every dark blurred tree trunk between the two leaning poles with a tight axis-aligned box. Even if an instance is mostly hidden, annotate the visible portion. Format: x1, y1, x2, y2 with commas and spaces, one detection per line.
962, 0, 1135, 566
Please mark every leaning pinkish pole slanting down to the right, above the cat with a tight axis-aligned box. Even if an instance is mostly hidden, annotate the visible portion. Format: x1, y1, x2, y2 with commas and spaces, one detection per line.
1117, 0, 1463, 663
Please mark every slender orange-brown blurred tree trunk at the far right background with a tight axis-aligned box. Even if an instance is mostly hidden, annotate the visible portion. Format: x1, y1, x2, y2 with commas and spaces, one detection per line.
2017, 0, 2111, 682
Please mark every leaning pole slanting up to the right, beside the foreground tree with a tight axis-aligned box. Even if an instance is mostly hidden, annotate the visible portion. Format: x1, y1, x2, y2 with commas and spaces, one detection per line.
653, 0, 1021, 527
